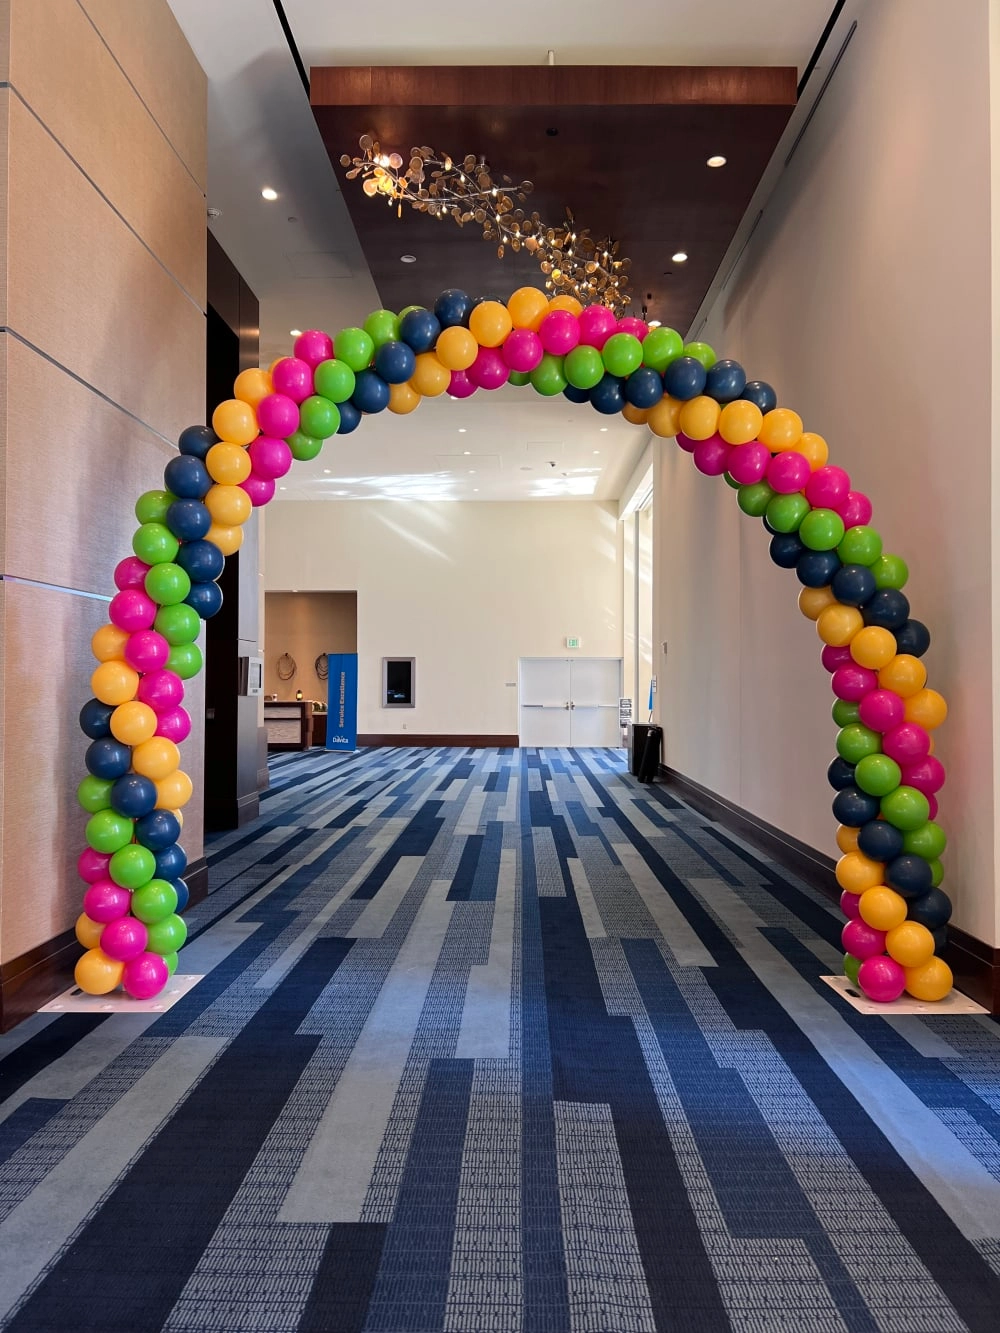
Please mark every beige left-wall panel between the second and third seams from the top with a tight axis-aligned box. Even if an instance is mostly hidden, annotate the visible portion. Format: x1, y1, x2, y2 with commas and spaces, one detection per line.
5, 99, 205, 440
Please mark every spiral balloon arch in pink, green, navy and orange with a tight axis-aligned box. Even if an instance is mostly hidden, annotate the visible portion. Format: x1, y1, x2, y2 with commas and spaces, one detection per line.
76, 287, 952, 1001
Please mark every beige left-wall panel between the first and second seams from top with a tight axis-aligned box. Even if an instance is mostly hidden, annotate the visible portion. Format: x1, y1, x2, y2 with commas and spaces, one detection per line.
11, 0, 207, 308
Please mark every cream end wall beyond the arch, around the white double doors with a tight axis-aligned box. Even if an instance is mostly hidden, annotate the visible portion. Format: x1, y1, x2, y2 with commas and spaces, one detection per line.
264, 501, 623, 734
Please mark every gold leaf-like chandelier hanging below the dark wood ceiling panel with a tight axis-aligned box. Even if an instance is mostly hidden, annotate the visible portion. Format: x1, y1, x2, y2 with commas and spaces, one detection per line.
340, 135, 632, 313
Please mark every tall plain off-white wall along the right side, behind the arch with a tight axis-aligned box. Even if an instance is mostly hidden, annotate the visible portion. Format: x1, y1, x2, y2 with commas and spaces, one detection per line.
653, 0, 1000, 942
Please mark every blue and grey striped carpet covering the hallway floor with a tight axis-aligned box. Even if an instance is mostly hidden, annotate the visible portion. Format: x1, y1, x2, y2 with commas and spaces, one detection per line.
0, 749, 1000, 1333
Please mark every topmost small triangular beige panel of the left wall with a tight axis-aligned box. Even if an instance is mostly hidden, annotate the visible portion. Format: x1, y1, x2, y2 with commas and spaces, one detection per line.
78, 0, 208, 192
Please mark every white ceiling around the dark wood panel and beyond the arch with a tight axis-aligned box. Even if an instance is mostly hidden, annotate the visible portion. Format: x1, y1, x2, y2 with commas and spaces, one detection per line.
168, 0, 832, 500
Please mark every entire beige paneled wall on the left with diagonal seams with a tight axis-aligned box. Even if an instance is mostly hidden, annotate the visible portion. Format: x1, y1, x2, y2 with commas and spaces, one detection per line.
0, 0, 207, 1002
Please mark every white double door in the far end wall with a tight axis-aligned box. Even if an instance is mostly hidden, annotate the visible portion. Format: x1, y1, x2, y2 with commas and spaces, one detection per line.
517, 657, 621, 746
